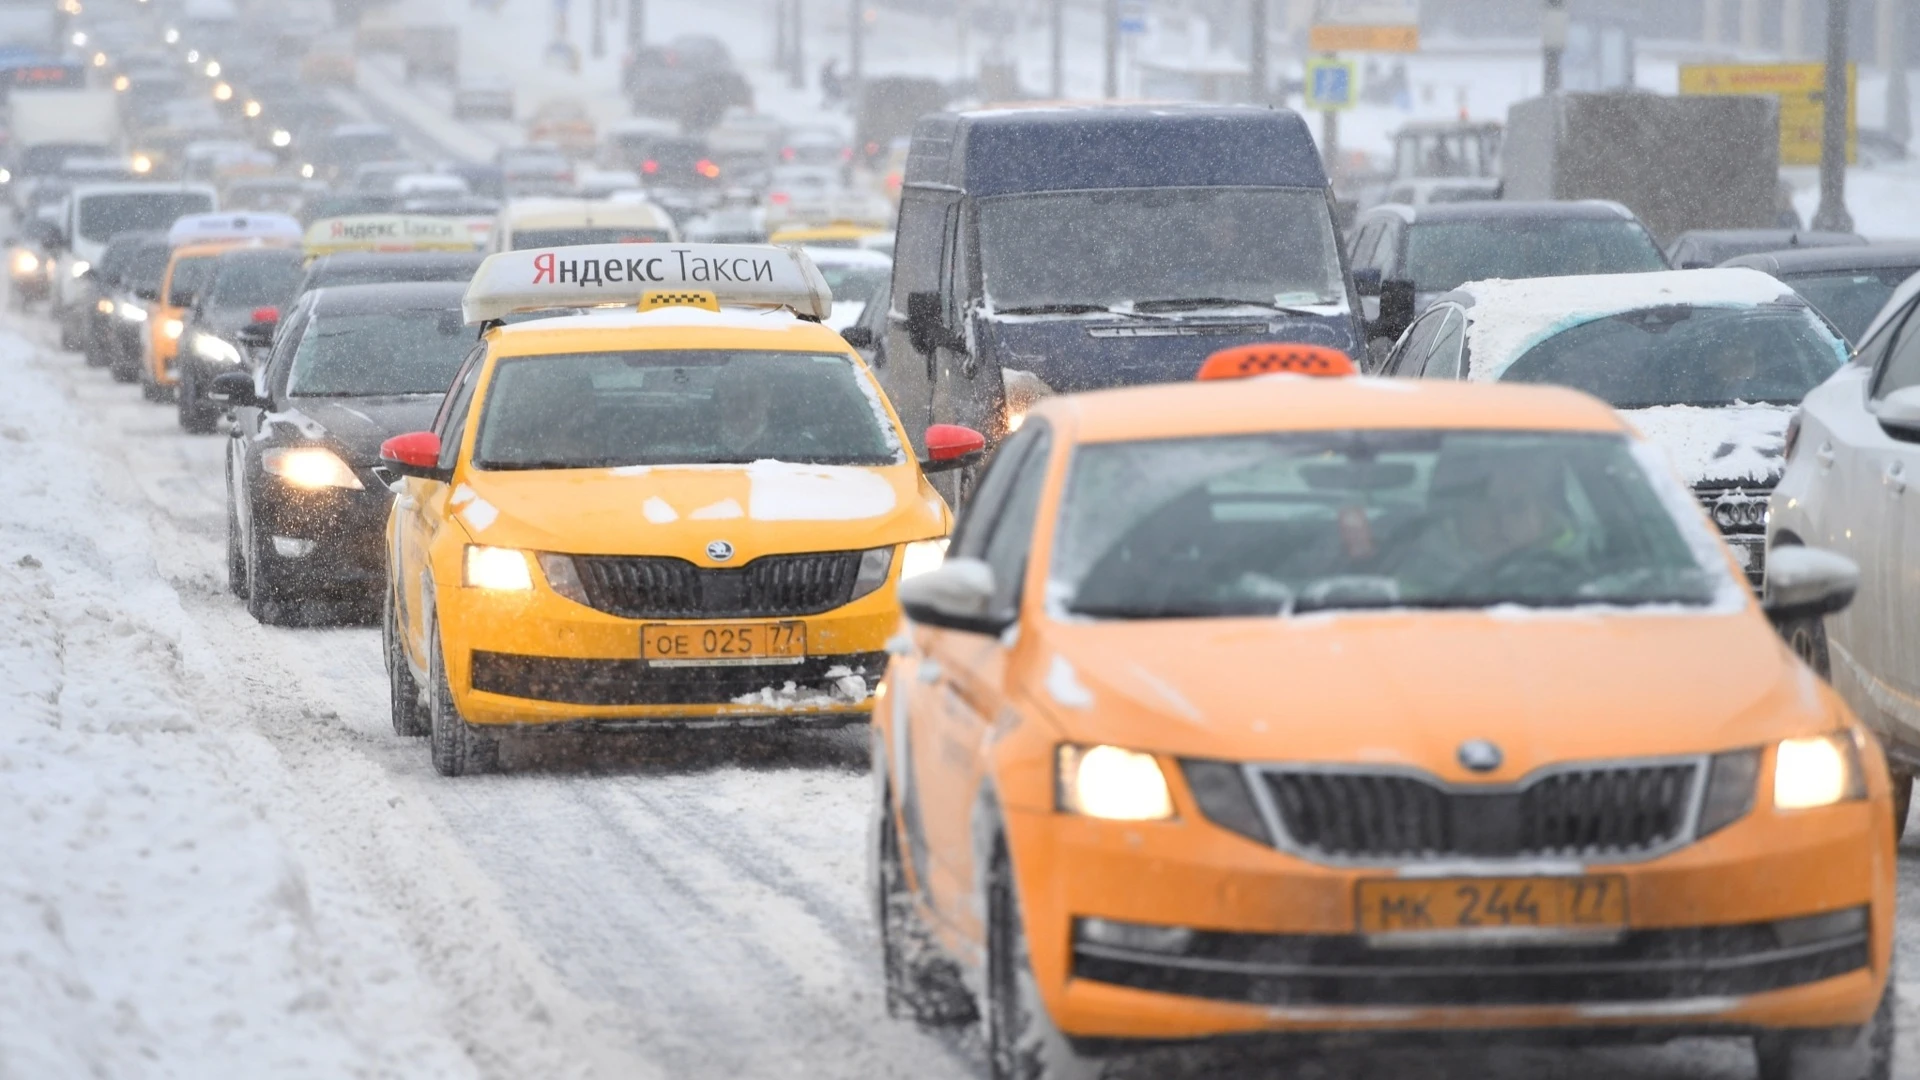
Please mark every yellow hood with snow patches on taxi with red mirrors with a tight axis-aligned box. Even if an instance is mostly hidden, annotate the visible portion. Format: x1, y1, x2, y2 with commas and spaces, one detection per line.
435, 461, 950, 553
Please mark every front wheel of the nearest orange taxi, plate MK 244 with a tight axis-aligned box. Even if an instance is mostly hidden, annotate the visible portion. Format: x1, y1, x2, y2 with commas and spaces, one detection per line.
987, 842, 1100, 1080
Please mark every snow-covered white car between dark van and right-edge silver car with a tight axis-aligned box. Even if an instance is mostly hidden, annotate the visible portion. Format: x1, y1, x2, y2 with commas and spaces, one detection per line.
1382, 269, 1847, 586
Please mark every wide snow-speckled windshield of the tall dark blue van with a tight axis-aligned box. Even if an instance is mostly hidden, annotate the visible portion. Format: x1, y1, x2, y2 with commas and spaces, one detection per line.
979, 188, 1346, 313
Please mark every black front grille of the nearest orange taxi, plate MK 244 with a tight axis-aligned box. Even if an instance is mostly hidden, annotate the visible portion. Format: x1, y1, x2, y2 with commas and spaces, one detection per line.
1261, 763, 1705, 859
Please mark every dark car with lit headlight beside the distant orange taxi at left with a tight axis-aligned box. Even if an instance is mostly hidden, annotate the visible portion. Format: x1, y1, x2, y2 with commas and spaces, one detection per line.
173, 248, 305, 432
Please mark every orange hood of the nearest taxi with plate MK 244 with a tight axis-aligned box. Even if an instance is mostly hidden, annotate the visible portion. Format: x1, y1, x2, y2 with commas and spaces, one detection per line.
1018, 601, 1837, 780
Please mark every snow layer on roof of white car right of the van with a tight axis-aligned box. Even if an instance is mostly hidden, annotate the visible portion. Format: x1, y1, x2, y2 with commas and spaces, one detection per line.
1453, 267, 1803, 382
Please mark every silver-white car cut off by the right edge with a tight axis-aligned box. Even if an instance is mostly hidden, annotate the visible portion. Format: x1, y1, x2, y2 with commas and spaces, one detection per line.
1774, 271, 1920, 828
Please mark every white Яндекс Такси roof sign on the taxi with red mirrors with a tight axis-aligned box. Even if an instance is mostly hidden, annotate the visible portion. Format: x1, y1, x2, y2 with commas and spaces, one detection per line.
461, 244, 833, 323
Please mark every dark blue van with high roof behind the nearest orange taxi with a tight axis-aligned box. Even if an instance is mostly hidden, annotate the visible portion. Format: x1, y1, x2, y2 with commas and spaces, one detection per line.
877, 106, 1365, 474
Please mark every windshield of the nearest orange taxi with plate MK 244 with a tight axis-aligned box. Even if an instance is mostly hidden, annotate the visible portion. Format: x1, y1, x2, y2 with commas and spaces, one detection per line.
1050, 430, 1730, 619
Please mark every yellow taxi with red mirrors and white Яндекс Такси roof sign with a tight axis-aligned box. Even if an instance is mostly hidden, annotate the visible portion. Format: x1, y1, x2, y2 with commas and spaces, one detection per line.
382, 244, 983, 774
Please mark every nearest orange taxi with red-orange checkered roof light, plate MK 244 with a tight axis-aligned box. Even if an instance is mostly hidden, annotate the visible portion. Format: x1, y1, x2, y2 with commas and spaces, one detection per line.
872, 346, 1895, 1080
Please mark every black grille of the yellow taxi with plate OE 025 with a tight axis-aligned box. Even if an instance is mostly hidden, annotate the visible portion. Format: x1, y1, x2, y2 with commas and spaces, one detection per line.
574, 552, 860, 619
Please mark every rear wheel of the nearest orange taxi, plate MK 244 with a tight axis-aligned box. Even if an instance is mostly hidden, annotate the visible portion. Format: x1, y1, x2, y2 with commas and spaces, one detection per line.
874, 780, 979, 1028
